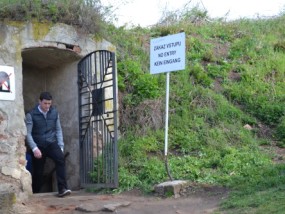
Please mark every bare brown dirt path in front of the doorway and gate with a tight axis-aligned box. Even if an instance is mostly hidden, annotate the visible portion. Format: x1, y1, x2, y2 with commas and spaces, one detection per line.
16, 187, 228, 214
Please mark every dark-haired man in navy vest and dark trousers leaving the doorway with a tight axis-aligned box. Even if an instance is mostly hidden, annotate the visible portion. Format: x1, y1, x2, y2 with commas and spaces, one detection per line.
25, 92, 71, 197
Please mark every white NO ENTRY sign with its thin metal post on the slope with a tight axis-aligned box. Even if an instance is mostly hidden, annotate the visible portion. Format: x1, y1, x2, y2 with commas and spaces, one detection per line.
150, 32, 185, 181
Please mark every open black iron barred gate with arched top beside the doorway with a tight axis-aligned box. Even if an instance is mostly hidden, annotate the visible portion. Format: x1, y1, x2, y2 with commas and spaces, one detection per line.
78, 50, 118, 188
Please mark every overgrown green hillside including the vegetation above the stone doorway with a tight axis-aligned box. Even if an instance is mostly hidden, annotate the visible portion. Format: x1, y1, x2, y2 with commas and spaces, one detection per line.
0, 0, 285, 214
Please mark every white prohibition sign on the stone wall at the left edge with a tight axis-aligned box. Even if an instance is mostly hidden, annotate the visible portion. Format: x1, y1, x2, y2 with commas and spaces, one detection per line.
0, 65, 16, 100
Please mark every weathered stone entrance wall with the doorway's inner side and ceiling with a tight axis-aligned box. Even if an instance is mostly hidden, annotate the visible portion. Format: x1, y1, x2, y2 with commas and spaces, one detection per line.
0, 22, 115, 213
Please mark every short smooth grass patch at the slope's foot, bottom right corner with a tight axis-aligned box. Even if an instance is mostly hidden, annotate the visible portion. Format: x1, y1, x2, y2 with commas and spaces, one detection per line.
221, 164, 285, 214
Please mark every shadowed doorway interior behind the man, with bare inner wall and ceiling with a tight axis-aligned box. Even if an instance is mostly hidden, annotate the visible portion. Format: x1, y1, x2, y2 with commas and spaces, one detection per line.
22, 47, 81, 192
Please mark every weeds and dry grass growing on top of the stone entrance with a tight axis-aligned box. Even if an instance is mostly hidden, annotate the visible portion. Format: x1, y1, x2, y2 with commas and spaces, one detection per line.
0, 0, 109, 34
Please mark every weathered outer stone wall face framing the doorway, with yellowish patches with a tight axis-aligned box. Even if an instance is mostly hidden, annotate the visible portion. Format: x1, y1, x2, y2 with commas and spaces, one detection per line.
0, 22, 115, 213
